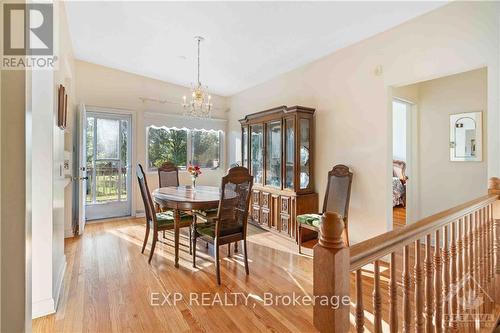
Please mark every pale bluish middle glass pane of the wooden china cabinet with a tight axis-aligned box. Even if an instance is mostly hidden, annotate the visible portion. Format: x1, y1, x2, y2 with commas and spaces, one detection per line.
266, 121, 281, 187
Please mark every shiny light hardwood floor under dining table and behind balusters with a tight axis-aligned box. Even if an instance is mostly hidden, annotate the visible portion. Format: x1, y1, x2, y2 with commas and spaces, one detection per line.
33, 219, 499, 333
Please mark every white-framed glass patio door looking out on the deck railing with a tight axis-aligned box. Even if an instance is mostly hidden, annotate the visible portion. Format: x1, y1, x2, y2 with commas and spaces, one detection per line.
85, 112, 131, 220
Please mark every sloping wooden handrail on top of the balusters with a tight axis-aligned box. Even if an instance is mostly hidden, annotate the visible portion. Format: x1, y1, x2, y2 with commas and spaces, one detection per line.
350, 194, 499, 271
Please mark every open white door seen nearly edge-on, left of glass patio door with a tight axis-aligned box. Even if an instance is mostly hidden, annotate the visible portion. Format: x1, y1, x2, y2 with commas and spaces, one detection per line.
75, 104, 88, 235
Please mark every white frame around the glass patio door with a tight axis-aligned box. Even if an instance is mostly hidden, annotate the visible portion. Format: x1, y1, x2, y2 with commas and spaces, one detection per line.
85, 105, 137, 223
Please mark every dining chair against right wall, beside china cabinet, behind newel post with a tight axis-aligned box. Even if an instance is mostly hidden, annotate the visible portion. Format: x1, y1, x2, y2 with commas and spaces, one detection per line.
297, 164, 353, 253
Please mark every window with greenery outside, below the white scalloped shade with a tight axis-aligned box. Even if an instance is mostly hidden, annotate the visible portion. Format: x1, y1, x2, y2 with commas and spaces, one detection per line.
147, 127, 222, 170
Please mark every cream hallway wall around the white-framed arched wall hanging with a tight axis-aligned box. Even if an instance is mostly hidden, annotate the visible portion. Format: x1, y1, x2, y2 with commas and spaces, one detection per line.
416, 69, 486, 218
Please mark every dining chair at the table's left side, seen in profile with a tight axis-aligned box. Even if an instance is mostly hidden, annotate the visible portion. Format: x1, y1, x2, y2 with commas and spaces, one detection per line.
136, 164, 192, 263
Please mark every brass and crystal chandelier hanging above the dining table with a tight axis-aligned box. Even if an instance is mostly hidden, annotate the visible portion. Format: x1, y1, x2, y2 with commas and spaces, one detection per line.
182, 36, 212, 118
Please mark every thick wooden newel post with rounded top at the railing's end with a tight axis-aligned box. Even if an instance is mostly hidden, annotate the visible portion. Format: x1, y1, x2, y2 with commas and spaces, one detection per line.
313, 212, 350, 333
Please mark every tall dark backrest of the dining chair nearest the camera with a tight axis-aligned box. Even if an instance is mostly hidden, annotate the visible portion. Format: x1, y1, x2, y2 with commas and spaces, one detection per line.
215, 167, 253, 237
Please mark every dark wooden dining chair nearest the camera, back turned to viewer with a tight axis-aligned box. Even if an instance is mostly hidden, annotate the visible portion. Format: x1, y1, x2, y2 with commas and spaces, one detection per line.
192, 167, 253, 285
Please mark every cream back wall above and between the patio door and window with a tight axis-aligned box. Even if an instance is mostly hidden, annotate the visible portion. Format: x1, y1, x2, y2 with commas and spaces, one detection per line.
76, 61, 228, 214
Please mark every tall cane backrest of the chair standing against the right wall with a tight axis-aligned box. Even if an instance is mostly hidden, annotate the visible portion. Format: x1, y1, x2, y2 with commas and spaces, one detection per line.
323, 164, 352, 221
